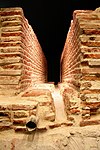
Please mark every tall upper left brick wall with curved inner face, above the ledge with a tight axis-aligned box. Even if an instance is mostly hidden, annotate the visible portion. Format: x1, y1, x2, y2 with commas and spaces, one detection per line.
0, 8, 47, 95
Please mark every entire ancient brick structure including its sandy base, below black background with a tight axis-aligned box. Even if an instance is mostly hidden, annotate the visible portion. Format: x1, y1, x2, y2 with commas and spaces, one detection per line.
0, 8, 100, 150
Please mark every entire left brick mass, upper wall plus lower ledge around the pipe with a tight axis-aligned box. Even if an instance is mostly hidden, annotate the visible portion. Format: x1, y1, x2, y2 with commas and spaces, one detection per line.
0, 8, 55, 132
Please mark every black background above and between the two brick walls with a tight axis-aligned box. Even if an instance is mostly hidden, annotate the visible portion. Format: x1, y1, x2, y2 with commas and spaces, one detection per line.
0, 0, 100, 83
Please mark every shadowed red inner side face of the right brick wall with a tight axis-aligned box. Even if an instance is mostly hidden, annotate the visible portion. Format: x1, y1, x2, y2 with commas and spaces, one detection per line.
61, 17, 81, 88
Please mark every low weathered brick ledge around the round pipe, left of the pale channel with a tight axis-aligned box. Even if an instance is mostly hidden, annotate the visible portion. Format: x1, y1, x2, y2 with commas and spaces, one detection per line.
0, 90, 55, 132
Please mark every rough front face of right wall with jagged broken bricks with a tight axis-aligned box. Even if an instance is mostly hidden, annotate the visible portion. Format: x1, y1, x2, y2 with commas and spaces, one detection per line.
74, 8, 100, 126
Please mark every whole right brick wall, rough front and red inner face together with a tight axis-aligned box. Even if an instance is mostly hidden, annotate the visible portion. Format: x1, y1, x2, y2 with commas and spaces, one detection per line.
61, 8, 100, 126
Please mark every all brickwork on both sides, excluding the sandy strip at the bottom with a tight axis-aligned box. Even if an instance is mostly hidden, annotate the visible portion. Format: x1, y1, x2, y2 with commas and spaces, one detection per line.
0, 5, 100, 141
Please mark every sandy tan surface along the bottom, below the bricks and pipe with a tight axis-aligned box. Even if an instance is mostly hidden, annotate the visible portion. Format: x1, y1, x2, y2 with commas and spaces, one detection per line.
0, 125, 100, 150
